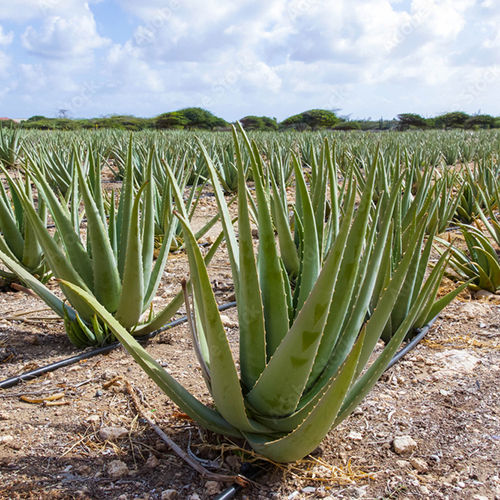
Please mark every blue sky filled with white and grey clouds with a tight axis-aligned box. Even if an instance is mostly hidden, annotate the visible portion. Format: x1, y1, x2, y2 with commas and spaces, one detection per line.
0, 0, 500, 120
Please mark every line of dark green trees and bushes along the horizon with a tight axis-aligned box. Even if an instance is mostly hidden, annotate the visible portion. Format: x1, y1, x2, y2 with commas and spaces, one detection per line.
2, 108, 500, 131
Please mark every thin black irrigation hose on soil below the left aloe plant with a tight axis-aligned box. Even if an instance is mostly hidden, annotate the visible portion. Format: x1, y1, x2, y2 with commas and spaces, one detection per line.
0, 302, 236, 389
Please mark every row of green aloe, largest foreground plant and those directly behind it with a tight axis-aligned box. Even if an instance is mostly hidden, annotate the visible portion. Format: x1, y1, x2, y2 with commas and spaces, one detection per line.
58, 127, 468, 462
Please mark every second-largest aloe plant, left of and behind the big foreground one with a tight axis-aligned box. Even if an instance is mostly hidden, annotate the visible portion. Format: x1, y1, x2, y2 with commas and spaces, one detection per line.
0, 141, 208, 347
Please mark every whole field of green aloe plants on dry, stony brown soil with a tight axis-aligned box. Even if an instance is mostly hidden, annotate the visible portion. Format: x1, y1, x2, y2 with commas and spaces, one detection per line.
0, 126, 500, 500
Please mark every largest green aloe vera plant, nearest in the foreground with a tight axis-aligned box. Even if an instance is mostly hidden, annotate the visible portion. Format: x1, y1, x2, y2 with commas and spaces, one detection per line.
60, 127, 456, 462
